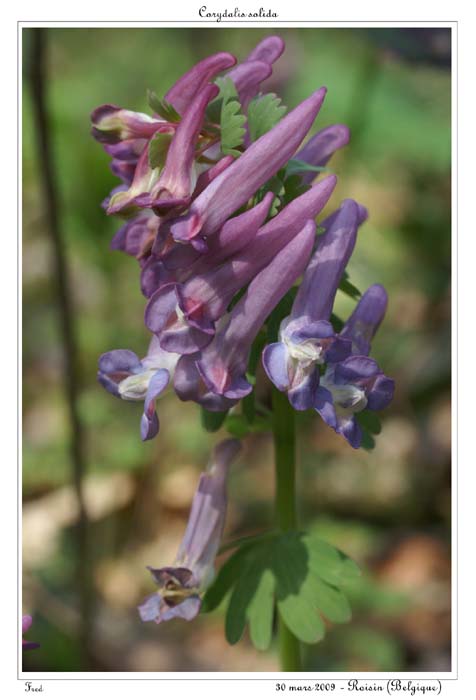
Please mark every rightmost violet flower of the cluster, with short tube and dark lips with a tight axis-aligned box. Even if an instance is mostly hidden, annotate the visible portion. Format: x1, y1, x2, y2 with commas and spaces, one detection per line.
314, 284, 395, 448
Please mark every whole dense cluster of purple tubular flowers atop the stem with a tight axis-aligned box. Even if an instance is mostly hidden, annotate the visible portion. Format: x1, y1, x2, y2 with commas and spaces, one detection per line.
92, 36, 393, 448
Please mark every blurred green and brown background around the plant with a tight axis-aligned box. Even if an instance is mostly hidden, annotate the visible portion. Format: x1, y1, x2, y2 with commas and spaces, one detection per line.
23, 28, 451, 672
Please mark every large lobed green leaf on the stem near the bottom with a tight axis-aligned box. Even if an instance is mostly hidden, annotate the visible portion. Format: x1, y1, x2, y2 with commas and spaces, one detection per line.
203, 532, 360, 650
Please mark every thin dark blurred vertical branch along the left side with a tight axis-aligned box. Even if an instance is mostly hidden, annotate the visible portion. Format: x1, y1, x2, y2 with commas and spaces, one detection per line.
27, 29, 92, 670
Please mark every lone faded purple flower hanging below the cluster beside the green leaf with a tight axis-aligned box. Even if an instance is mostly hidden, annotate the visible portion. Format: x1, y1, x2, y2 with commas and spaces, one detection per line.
138, 440, 240, 624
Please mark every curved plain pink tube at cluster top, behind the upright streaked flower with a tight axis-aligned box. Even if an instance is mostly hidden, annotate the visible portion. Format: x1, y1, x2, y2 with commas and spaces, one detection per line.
165, 53, 236, 114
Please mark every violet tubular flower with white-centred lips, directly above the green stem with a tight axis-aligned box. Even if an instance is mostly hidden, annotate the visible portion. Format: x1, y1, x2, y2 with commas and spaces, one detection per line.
263, 198, 359, 411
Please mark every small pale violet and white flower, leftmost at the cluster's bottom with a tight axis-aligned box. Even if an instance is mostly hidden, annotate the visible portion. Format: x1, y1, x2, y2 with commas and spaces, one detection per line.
98, 337, 178, 440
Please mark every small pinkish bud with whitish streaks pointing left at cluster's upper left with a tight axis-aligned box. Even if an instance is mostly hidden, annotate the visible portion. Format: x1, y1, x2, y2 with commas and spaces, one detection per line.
91, 105, 170, 144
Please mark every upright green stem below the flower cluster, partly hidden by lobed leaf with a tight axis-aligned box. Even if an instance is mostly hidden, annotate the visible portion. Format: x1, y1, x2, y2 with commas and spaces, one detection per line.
273, 387, 301, 671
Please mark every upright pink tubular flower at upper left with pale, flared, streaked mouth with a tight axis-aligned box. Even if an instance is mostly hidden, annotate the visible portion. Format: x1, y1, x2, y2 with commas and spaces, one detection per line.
135, 85, 218, 214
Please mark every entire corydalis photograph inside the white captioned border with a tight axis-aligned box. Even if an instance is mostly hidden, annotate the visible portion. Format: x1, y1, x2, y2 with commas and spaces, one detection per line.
18, 22, 455, 678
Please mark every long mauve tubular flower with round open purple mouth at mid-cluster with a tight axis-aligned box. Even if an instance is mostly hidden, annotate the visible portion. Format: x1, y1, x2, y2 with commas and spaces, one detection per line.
145, 177, 335, 354
